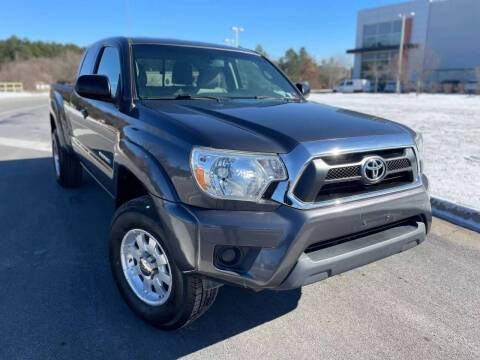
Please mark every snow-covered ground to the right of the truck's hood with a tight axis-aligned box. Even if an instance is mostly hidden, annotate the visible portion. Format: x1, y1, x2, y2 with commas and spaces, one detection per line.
310, 93, 480, 209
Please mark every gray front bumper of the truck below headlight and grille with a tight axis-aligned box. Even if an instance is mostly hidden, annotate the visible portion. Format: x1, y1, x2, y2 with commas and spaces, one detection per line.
151, 178, 431, 290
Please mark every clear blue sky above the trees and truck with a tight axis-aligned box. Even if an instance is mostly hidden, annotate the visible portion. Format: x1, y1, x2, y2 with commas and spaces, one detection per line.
0, 0, 400, 60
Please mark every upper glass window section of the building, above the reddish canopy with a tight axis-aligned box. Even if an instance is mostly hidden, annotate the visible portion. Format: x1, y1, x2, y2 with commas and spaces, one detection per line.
363, 20, 402, 48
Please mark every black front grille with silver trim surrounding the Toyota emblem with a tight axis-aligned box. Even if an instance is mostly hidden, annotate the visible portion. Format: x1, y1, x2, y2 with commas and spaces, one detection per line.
293, 148, 418, 203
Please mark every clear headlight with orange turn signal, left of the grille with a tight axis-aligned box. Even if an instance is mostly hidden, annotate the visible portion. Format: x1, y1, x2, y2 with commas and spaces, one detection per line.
190, 148, 287, 201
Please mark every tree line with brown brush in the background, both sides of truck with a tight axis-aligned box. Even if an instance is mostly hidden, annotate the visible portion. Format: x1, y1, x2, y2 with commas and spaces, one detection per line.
0, 36, 350, 90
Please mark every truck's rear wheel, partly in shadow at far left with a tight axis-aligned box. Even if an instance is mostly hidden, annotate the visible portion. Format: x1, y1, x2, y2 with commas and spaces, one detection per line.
52, 129, 82, 188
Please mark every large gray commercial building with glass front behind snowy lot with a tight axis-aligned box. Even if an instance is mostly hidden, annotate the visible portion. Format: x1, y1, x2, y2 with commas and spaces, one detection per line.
347, 0, 480, 90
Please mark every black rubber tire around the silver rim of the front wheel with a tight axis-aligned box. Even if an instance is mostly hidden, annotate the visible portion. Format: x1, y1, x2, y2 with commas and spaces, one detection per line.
109, 196, 218, 330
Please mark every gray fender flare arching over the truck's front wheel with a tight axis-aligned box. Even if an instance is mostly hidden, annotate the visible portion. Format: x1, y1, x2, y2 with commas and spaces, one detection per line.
114, 139, 180, 202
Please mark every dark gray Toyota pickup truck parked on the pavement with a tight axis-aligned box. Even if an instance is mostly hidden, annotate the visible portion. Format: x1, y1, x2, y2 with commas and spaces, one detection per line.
50, 38, 431, 329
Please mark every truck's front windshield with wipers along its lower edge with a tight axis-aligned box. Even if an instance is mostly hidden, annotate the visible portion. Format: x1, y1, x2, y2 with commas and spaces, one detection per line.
133, 45, 299, 100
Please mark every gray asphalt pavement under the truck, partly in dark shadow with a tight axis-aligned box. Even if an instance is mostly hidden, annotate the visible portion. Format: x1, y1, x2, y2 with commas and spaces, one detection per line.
0, 99, 480, 360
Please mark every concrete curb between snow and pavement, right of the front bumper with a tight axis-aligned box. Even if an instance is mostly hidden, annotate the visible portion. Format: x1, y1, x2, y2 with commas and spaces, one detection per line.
430, 197, 480, 233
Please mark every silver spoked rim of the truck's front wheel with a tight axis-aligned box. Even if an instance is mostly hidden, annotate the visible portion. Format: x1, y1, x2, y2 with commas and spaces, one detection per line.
120, 229, 172, 305
